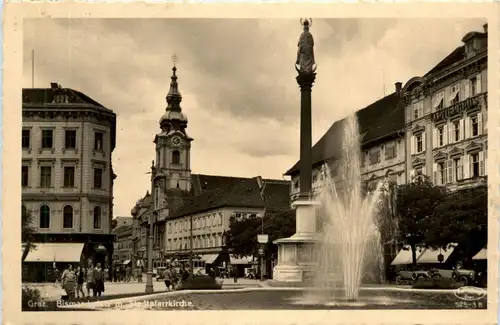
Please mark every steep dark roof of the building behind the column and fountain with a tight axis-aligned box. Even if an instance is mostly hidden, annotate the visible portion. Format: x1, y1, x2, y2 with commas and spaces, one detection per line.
285, 92, 405, 175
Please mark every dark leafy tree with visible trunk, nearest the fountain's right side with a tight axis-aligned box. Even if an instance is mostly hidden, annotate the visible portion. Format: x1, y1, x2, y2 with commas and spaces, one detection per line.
396, 175, 447, 265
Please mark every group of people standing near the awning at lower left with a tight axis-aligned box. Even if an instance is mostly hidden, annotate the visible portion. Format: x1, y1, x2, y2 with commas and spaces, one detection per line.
55, 263, 106, 300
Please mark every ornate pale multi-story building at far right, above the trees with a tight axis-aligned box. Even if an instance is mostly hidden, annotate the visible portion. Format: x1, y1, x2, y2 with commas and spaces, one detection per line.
403, 25, 488, 190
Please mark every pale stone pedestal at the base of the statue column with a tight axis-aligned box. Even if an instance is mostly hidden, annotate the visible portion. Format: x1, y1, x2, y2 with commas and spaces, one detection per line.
273, 199, 319, 285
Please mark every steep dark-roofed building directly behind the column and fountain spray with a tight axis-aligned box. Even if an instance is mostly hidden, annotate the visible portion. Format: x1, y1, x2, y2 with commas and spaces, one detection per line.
285, 82, 406, 197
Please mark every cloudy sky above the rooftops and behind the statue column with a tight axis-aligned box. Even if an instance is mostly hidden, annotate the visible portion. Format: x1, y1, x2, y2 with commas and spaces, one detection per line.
23, 18, 485, 216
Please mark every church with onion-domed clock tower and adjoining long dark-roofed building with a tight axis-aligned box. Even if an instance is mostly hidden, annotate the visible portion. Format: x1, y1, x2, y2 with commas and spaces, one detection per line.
131, 67, 289, 270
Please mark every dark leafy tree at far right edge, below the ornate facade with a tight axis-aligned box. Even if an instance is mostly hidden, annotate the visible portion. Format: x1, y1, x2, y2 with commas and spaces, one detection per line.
426, 186, 488, 259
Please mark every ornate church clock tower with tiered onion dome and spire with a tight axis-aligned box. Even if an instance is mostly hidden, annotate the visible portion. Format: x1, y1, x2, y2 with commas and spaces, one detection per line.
154, 63, 193, 197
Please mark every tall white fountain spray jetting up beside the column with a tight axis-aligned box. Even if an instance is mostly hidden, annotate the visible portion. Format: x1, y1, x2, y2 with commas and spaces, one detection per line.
308, 115, 384, 301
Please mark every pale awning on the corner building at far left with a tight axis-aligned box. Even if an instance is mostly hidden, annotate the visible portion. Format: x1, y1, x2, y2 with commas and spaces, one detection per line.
24, 243, 84, 262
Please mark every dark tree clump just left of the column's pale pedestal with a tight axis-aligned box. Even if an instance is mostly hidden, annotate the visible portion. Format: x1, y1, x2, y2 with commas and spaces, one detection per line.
226, 210, 295, 256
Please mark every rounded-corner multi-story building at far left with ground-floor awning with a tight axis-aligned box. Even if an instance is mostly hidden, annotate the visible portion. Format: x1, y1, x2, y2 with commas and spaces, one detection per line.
21, 83, 116, 278
